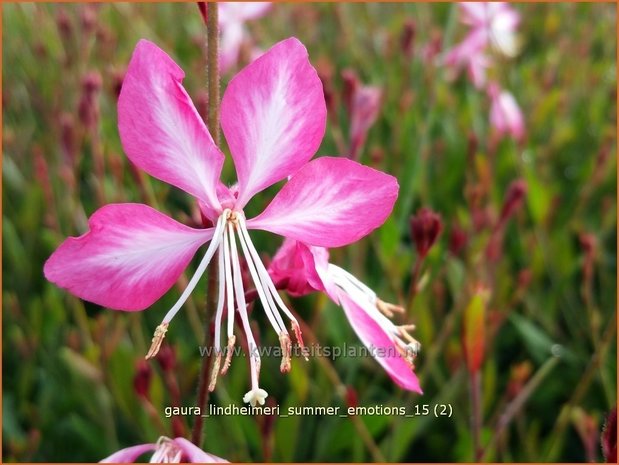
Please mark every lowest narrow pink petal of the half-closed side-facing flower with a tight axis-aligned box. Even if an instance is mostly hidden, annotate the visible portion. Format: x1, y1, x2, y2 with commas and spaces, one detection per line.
338, 290, 422, 394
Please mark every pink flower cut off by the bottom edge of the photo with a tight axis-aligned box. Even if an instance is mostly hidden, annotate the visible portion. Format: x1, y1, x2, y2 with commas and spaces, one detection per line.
100, 436, 228, 463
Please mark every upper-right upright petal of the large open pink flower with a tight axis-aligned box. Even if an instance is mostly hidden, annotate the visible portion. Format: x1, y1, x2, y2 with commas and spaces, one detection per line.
221, 38, 327, 208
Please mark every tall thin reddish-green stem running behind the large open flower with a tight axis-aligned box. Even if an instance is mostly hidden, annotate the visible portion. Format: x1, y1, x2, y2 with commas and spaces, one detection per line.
191, 2, 220, 447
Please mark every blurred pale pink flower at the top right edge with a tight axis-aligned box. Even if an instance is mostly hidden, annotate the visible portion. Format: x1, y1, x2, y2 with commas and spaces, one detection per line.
443, 2, 520, 88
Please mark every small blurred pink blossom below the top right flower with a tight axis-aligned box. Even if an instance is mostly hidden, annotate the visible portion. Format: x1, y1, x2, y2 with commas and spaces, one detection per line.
488, 83, 525, 142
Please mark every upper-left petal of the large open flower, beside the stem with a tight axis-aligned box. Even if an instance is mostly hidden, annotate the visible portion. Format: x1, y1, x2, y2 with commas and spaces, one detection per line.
118, 40, 224, 214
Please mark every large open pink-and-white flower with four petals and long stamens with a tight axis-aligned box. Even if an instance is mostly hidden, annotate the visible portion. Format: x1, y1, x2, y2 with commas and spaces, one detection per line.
44, 38, 398, 405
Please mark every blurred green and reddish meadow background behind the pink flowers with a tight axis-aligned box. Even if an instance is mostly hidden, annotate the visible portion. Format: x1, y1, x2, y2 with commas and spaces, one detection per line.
2, 3, 617, 462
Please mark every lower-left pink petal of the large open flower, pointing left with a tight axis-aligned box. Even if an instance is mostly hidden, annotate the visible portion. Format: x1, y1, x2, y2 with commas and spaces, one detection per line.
44, 203, 213, 311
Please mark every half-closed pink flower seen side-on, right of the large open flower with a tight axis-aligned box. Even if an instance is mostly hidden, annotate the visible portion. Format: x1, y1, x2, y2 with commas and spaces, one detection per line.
269, 239, 422, 393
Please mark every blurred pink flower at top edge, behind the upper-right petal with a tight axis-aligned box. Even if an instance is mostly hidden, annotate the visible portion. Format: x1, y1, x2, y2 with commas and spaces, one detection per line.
218, 2, 271, 73
